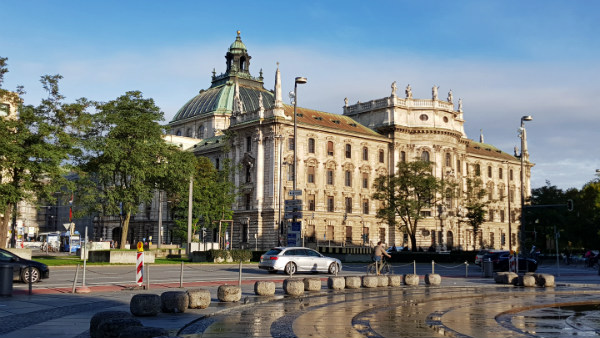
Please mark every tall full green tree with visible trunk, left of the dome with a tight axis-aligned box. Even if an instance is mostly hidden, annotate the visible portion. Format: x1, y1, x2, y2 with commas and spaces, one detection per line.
78, 91, 192, 248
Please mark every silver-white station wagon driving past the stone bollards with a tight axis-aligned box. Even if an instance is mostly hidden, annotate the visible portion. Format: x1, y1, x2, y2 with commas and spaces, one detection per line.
258, 247, 342, 275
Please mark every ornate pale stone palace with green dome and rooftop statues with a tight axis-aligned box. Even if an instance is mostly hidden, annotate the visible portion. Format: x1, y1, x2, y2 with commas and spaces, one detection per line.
162, 32, 533, 254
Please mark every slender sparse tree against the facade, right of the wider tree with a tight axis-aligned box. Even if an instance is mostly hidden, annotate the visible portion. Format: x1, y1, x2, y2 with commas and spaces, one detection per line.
465, 177, 490, 250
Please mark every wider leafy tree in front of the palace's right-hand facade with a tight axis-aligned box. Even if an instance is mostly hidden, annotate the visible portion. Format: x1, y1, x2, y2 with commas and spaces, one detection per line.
373, 160, 444, 251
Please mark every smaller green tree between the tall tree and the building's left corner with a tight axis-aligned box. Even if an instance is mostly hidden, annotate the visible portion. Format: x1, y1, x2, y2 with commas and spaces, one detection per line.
175, 156, 236, 240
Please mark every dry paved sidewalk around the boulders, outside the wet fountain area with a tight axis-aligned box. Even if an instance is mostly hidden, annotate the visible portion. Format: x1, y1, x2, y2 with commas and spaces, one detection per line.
0, 269, 600, 338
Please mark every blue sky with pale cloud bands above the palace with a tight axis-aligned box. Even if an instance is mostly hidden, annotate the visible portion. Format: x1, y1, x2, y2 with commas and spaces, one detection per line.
0, 0, 600, 189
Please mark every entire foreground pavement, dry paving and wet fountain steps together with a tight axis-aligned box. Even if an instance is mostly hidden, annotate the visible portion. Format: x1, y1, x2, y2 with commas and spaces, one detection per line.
0, 270, 600, 338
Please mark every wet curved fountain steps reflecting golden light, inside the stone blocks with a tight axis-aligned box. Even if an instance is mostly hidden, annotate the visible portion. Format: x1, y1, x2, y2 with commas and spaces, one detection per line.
179, 287, 600, 338
